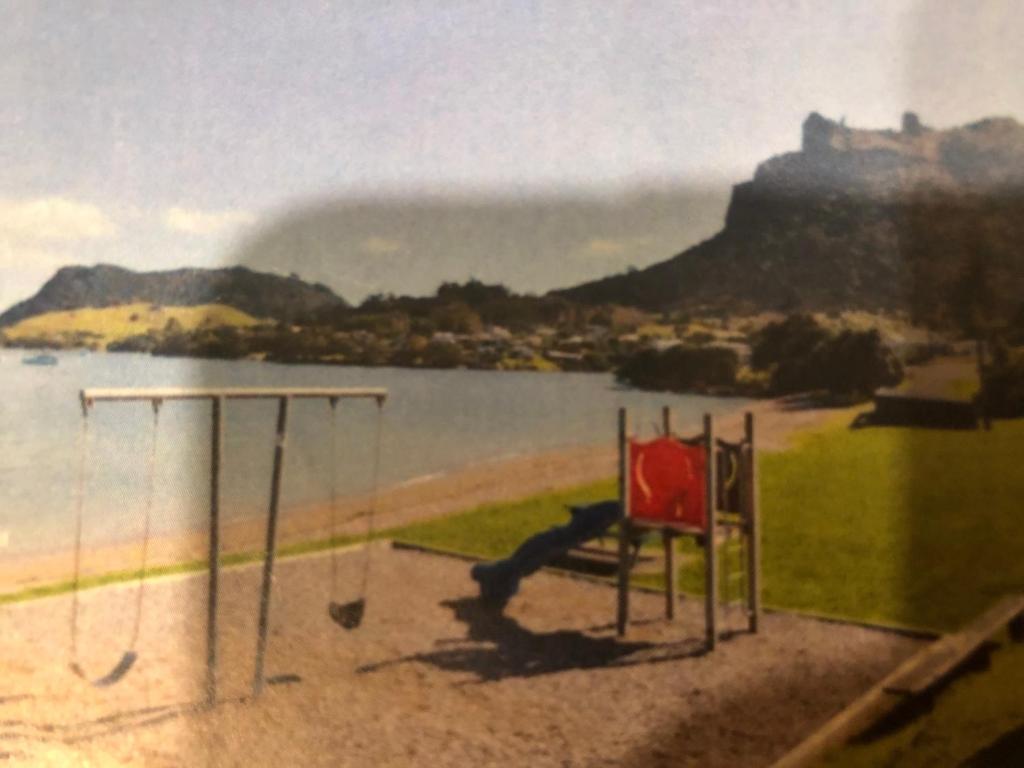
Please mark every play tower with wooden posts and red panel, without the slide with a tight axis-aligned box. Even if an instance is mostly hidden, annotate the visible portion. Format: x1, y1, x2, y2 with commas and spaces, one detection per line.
615, 407, 761, 650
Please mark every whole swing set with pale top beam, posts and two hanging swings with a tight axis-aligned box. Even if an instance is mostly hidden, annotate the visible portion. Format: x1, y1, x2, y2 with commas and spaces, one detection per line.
69, 387, 387, 707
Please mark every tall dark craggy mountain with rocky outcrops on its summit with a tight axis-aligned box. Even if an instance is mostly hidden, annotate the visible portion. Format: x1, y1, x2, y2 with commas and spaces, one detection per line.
553, 113, 1024, 323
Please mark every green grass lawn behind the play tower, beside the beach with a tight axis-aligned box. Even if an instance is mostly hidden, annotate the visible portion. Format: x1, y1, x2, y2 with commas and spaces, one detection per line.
389, 422, 1024, 630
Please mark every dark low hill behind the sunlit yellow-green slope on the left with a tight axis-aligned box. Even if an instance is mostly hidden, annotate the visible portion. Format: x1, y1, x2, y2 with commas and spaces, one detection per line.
0, 264, 347, 328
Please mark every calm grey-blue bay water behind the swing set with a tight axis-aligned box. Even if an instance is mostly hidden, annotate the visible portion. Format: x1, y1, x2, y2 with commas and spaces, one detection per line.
0, 349, 742, 556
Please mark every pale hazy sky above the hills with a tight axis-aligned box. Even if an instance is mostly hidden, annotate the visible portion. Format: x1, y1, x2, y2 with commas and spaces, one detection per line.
0, 0, 1024, 307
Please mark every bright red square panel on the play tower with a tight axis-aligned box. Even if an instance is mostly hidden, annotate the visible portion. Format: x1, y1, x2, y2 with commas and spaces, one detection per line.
629, 437, 707, 529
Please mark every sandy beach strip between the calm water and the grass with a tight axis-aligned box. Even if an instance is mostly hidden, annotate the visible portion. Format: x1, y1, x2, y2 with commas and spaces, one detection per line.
0, 400, 848, 602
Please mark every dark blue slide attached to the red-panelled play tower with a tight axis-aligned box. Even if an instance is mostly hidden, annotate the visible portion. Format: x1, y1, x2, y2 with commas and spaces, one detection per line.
469, 501, 620, 607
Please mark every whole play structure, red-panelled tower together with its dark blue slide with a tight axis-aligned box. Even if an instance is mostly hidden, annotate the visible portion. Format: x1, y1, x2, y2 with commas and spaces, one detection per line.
470, 408, 761, 650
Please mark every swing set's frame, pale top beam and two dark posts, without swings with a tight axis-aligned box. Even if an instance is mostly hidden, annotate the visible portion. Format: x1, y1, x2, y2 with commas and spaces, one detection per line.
79, 387, 388, 707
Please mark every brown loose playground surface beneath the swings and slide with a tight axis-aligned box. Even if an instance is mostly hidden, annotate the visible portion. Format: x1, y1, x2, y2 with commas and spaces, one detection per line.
0, 543, 919, 768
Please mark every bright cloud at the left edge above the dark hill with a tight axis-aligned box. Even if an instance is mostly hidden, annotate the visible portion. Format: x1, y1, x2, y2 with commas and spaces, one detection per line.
0, 197, 118, 243
